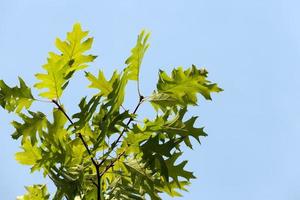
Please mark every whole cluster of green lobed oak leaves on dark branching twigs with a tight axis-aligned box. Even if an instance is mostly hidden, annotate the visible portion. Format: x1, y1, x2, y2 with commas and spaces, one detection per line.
0, 24, 222, 200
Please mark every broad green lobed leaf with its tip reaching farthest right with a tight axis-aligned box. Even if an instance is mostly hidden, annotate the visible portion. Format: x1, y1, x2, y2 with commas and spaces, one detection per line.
150, 65, 222, 110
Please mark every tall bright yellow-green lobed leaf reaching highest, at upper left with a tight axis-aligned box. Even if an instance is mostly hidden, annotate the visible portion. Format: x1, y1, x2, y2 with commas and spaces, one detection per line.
34, 23, 96, 99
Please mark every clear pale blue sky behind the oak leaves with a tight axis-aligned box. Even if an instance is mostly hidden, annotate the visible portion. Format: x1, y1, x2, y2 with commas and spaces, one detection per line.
0, 0, 300, 200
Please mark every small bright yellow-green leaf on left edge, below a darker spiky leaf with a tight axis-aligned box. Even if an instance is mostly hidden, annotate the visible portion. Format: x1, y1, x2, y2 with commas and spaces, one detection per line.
15, 139, 42, 165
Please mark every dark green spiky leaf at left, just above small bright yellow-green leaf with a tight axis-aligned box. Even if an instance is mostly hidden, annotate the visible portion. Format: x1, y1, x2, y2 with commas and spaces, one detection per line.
12, 111, 47, 144
